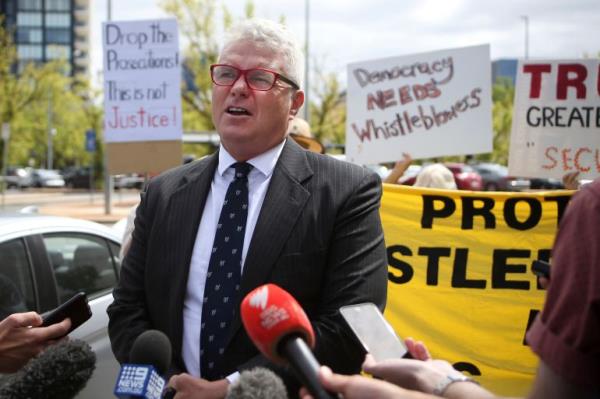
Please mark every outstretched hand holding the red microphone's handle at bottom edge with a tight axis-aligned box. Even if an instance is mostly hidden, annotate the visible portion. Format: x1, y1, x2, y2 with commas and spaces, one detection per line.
300, 366, 425, 399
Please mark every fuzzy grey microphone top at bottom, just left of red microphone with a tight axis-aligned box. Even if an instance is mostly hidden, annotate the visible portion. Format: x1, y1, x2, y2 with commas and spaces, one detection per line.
225, 367, 288, 399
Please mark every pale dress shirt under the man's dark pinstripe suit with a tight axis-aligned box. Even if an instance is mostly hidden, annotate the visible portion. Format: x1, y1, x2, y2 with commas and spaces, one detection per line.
181, 140, 285, 382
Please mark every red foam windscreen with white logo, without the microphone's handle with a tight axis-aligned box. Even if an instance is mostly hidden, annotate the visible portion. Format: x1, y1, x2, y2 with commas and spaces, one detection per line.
241, 284, 315, 364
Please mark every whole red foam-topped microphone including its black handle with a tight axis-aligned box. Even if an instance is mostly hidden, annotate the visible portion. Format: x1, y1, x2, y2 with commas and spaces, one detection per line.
241, 284, 335, 399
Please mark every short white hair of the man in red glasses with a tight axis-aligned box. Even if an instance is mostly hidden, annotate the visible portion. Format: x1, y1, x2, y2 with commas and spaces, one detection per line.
221, 19, 304, 86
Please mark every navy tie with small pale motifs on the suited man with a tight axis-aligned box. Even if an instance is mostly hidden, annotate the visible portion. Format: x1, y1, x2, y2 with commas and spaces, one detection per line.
200, 162, 252, 380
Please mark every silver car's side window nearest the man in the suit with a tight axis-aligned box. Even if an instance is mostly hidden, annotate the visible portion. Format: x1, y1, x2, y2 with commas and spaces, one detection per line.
43, 233, 117, 303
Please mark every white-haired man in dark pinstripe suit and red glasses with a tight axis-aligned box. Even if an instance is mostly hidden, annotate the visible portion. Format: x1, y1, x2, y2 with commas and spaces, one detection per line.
108, 20, 387, 398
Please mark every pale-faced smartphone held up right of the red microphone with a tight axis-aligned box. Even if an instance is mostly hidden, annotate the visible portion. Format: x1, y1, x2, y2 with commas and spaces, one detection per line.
340, 302, 410, 362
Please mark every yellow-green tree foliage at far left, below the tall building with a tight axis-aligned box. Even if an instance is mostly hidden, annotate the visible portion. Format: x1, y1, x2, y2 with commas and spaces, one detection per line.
0, 17, 101, 172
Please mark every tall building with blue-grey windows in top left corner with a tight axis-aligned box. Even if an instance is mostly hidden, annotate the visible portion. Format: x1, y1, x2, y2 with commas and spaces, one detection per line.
0, 0, 90, 75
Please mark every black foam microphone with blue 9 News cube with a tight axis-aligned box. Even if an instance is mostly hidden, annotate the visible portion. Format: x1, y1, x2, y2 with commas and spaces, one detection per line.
114, 330, 171, 399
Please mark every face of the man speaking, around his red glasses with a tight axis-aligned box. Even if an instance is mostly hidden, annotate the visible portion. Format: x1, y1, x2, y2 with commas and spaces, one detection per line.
212, 41, 304, 161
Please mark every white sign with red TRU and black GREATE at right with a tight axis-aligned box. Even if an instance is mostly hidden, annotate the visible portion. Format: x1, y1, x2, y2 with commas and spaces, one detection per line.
508, 59, 600, 178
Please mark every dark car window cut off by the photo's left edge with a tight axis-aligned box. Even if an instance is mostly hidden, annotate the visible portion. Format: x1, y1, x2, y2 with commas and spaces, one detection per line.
0, 239, 36, 320
